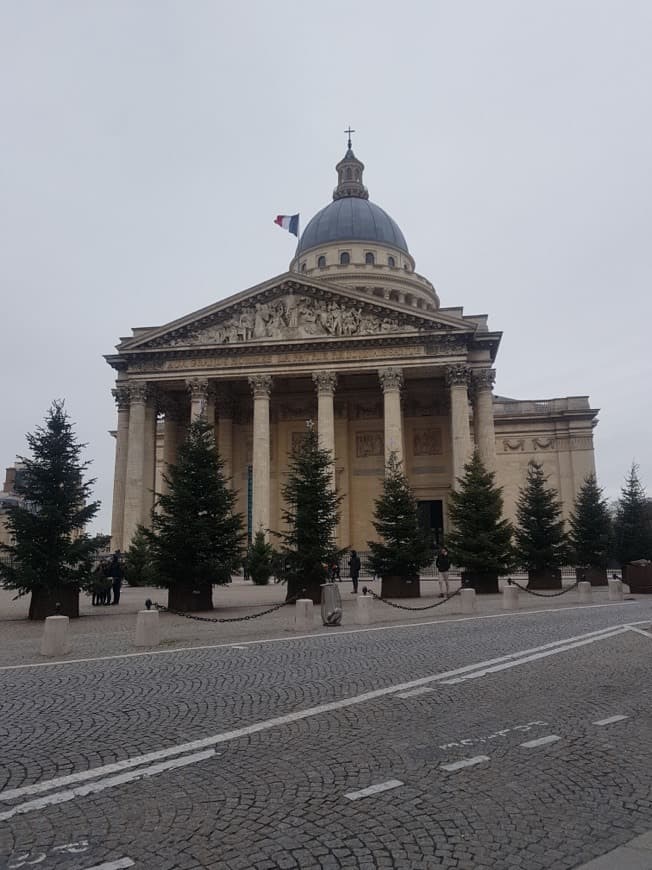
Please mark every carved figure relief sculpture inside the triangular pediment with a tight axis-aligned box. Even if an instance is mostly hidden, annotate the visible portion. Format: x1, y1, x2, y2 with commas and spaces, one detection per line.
138, 293, 444, 347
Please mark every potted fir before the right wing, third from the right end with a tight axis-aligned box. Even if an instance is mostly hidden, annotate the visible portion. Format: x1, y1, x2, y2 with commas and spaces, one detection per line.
514, 460, 568, 572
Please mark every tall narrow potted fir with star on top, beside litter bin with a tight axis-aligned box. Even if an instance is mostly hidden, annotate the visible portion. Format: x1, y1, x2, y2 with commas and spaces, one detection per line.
279, 422, 342, 603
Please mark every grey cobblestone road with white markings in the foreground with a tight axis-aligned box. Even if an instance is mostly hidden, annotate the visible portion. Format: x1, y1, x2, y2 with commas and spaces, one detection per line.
0, 599, 652, 870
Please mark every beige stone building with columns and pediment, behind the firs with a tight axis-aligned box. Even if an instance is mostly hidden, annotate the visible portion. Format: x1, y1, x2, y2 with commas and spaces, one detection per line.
107, 144, 597, 551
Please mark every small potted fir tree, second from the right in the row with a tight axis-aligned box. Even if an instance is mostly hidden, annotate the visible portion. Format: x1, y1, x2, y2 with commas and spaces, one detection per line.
569, 474, 612, 568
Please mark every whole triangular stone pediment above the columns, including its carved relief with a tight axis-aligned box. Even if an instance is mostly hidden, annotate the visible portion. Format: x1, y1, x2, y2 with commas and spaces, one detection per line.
119, 272, 475, 352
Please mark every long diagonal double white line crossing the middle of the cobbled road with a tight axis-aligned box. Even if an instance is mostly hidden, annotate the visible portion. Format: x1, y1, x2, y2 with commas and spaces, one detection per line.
0, 627, 640, 820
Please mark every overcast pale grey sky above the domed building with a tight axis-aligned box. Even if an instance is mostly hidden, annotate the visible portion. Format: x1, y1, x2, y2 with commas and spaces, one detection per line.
0, 0, 652, 531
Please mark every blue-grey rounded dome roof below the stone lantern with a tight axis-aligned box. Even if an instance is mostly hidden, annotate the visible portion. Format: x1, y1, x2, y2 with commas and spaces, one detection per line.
297, 196, 409, 254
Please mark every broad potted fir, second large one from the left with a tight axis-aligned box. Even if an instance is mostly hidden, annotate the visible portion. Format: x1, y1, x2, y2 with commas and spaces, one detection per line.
145, 419, 244, 610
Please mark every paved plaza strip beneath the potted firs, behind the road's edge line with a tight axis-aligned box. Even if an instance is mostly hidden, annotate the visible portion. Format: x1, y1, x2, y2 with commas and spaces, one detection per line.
0, 578, 636, 666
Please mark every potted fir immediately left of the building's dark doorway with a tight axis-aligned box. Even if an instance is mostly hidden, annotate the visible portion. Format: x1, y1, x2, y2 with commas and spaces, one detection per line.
367, 452, 432, 580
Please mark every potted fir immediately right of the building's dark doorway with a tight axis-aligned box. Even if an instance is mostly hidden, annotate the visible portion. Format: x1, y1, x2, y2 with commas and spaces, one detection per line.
446, 450, 512, 592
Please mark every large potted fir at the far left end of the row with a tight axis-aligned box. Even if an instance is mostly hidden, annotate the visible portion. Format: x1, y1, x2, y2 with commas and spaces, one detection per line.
0, 402, 107, 619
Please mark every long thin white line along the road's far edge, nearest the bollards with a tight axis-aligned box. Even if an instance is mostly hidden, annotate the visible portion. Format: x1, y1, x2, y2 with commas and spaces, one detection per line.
0, 601, 650, 671
